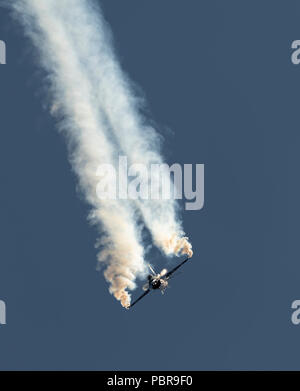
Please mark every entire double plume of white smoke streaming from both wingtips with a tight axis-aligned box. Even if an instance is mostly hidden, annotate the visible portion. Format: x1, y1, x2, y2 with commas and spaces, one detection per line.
11, 0, 192, 307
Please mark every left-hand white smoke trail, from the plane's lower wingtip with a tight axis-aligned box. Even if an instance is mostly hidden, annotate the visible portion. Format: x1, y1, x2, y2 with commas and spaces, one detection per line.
14, 0, 145, 306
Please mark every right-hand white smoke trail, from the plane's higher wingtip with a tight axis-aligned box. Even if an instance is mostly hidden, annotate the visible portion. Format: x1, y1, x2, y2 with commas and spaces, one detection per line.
52, 0, 193, 256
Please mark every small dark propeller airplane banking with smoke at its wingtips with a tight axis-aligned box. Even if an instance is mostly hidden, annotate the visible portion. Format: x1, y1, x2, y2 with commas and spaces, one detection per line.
127, 257, 190, 309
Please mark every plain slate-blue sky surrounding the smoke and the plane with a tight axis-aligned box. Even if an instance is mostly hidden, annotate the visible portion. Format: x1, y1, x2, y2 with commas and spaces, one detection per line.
0, 0, 300, 370
